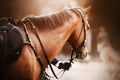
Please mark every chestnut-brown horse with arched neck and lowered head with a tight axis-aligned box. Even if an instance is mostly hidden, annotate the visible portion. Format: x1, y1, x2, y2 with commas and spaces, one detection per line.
0, 8, 90, 80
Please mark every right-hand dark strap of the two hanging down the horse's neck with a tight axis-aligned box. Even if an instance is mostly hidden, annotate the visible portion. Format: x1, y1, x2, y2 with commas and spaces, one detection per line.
26, 18, 58, 79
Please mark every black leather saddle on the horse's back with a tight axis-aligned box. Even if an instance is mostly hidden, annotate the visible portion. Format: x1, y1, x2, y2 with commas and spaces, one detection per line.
0, 18, 23, 64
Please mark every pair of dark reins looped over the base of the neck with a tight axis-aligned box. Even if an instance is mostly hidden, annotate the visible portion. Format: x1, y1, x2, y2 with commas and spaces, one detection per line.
23, 18, 58, 79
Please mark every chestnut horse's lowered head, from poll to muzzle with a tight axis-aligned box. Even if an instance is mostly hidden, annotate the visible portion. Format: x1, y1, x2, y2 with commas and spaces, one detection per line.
68, 8, 90, 59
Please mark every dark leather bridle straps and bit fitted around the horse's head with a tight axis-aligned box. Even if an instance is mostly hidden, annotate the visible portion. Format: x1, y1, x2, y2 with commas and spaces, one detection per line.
68, 8, 87, 62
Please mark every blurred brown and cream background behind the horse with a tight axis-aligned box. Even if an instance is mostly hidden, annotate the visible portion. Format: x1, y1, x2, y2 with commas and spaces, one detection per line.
0, 0, 120, 80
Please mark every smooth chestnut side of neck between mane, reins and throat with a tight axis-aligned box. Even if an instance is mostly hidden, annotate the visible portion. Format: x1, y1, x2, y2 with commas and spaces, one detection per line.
36, 16, 78, 64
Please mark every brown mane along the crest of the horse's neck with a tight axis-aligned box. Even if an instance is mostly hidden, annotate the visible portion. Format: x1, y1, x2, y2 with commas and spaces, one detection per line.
27, 9, 78, 28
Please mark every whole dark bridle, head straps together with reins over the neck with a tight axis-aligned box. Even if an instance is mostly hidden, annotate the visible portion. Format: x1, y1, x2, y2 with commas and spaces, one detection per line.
18, 8, 86, 80
